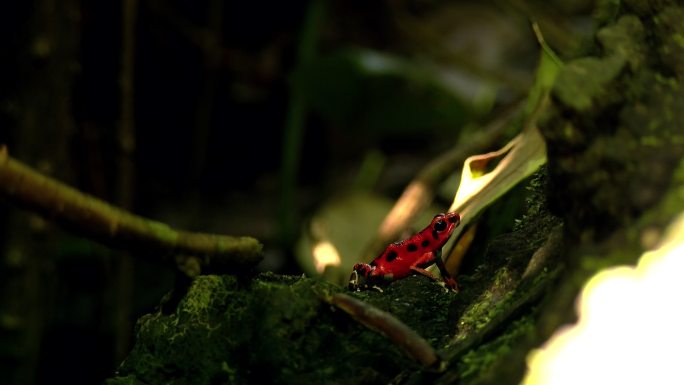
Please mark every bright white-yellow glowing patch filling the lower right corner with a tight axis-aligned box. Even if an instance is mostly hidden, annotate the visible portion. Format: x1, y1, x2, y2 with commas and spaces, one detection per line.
523, 215, 684, 385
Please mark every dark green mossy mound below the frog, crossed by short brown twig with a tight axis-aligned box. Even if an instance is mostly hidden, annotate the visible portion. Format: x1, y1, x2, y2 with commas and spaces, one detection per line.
105, 274, 454, 385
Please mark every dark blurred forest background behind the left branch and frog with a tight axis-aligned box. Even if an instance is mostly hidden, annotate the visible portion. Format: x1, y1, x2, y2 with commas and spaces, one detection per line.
0, 0, 591, 384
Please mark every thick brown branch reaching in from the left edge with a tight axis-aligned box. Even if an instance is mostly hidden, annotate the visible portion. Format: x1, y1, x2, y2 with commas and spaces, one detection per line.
0, 145, 262, 275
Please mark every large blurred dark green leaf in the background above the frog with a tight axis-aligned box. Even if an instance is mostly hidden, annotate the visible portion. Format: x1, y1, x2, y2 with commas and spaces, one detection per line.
292, 48, 472, 136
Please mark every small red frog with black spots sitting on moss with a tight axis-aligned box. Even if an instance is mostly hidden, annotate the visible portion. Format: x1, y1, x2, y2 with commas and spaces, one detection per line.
349, 213, 461, 291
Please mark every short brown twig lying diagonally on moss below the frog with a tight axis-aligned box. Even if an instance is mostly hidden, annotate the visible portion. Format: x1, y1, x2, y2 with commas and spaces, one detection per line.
323, 293, 444, 372
